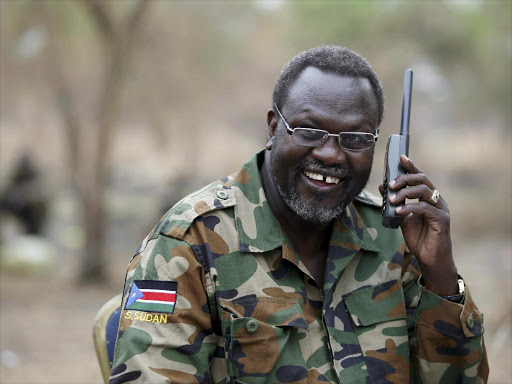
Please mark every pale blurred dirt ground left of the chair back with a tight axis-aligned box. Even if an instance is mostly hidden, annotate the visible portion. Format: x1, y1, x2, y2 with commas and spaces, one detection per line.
0, 274, 119, 384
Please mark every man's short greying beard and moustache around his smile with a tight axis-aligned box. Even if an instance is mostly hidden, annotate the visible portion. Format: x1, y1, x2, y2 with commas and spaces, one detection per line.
271, 158, 350, 225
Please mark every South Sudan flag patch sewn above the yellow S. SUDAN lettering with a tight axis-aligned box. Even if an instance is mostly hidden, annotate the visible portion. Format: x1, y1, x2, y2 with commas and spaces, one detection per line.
124, 280, 178, 313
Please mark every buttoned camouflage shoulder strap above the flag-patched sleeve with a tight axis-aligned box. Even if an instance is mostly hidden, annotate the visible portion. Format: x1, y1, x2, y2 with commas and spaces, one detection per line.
152, 176, 236, 240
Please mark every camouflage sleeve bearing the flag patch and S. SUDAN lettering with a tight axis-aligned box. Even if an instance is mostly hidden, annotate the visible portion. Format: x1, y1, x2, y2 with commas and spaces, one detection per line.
110, 235, 216, 384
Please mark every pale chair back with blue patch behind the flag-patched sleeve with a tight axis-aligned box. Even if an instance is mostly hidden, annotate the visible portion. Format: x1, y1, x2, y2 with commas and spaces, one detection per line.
92, 294, 122, 384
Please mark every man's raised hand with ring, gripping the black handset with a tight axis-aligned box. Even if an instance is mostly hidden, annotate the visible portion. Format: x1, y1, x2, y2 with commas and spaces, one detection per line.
380, 155, 458, 296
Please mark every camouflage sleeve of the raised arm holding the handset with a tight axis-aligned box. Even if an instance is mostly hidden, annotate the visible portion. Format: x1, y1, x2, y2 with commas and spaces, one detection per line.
402, 254, 489, 384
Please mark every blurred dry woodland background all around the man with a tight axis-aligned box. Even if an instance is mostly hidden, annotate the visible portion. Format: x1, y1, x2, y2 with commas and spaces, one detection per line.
0, 0, 512, 383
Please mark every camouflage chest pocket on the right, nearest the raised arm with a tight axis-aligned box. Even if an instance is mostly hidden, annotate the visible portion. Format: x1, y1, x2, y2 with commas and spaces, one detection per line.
344, 280, 409, 383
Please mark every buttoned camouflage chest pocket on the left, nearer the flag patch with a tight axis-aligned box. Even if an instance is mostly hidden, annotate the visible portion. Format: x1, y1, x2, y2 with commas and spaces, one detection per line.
219, 295, 308, 383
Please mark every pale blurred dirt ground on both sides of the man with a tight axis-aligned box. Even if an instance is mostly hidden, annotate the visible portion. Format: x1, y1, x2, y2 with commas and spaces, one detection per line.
0, 236, 512, 384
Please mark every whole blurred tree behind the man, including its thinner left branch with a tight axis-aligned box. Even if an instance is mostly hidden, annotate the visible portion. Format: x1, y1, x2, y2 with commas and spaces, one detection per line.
45, 0, 150, 282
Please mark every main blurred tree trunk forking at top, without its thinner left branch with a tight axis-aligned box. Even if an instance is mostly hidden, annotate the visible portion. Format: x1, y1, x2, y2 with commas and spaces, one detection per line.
80, 0, 149, 282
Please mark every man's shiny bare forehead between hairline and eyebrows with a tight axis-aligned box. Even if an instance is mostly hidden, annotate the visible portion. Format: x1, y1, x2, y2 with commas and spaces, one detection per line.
283, 67, 378, 124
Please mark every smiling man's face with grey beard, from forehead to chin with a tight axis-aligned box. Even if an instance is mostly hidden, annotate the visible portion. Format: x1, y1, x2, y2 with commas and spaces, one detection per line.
267, 67, 378, 224
